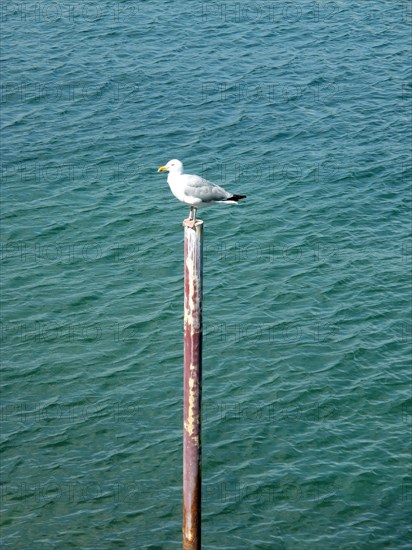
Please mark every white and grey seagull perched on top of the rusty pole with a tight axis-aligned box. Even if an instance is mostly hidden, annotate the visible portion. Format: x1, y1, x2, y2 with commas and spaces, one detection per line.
158, 159, 246, 227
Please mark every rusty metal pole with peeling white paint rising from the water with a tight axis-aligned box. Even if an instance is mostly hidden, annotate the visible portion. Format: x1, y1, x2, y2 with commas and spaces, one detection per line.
183, 220, 203, 550
